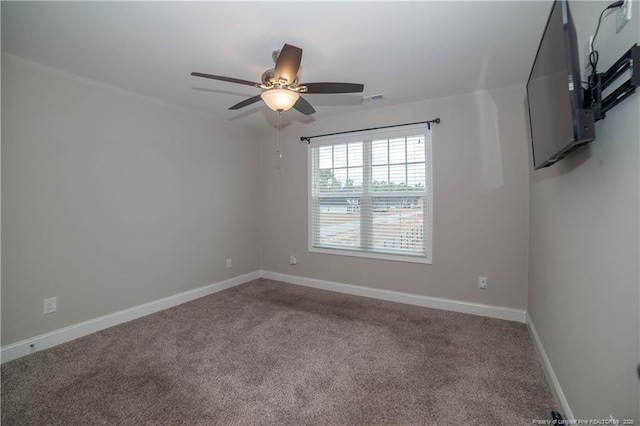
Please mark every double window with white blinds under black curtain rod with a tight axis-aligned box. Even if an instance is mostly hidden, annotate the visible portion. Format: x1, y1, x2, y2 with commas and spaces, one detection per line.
309, 125, 433, 263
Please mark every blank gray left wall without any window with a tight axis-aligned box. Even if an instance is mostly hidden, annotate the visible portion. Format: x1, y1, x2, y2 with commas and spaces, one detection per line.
2, 54, 260, 345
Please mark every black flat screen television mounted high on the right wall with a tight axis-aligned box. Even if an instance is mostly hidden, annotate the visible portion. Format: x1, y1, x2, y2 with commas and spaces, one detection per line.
527, 0, 595, 169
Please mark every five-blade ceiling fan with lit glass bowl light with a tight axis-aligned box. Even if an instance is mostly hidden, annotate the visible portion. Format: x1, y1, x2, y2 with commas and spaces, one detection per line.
191, 44, 364, 115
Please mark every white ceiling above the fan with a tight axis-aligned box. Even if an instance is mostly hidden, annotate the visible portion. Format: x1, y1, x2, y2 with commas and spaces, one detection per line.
2, 1, 551, 127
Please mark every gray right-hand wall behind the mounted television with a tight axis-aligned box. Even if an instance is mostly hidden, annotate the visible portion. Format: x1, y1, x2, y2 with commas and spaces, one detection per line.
527, 1, 640, 423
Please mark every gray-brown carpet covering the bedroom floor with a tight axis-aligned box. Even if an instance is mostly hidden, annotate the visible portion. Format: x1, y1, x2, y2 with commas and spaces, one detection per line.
1, 279, 555, 425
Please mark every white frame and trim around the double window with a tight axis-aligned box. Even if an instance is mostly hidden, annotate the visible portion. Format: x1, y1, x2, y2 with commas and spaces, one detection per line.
307, 124, 434, 265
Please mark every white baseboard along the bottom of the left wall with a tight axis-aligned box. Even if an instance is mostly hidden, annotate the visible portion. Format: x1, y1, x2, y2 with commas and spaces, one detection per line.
0, 271, 261, 363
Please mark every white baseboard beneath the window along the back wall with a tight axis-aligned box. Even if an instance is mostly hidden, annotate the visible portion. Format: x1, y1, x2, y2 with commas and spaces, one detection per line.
261, 271, 526, 323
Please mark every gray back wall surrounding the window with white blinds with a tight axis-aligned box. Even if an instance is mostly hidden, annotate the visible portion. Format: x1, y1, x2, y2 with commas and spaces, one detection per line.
260, 87, 529, 308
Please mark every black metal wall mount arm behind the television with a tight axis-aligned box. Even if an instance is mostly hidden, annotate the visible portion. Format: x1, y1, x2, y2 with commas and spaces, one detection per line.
584, 43, 640, 121
